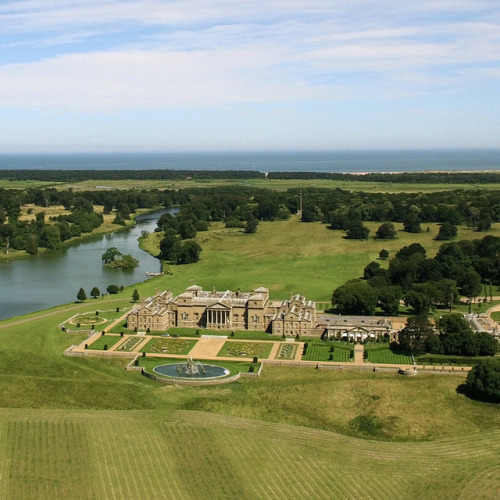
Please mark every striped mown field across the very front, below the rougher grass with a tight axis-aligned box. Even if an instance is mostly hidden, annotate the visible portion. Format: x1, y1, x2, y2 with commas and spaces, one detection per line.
0, 410, 500, 500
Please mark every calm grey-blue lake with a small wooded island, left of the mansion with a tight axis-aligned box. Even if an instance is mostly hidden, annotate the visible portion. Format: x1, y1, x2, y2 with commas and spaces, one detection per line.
0, 209, 172, 319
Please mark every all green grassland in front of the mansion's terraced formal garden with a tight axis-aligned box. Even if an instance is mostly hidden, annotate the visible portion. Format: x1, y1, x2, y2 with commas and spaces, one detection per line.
0, 306, 500, 500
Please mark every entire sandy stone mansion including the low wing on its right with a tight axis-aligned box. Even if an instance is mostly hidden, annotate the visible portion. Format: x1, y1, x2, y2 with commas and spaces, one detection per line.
127, 285, 397, 342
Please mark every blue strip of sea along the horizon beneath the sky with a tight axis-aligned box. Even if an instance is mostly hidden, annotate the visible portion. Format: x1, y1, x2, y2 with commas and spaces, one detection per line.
0, 149, 500, 173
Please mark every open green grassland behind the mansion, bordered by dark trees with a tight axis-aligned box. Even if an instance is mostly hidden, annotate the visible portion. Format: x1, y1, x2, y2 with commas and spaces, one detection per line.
139, 217, 500, 302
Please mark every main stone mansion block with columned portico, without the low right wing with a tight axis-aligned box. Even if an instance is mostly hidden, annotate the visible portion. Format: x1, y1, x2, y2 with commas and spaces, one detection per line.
127, 285, 316, 336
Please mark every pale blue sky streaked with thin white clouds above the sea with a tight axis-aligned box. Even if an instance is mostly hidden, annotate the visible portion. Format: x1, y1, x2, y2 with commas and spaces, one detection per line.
0, 0, 500, 153
